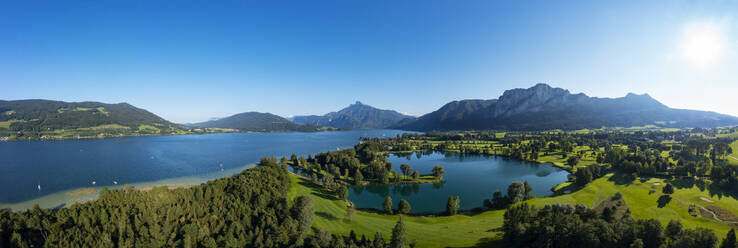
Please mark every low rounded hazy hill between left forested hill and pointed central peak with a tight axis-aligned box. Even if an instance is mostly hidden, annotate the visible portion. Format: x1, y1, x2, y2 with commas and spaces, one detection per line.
190, 112, 321, 132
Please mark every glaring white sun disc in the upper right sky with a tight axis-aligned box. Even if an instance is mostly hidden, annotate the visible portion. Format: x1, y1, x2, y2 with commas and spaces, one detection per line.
681, 23, 726, 69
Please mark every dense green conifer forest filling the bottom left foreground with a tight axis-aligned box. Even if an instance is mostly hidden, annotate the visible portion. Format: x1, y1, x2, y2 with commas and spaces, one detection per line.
0, 158, 396, 247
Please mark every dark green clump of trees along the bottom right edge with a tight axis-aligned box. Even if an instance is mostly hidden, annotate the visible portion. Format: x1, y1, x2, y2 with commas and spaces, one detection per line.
502, 200, 736, 248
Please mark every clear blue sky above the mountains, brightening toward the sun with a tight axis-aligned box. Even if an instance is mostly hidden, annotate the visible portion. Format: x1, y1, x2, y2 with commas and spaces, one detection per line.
0, 1, 738, 122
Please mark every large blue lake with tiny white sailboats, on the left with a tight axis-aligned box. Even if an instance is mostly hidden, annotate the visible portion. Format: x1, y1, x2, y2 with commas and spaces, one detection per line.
0, 130, 403, 209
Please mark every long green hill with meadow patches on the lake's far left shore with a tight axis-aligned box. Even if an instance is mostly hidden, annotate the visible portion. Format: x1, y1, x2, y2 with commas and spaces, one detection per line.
0, 100, 190, 139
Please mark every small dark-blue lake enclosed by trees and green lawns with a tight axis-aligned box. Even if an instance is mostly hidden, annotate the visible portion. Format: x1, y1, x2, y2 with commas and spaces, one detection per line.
348, 152, 569, 213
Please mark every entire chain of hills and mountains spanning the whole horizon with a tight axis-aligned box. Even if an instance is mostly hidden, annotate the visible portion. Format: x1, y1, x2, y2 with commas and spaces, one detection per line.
0, 84, 738, 138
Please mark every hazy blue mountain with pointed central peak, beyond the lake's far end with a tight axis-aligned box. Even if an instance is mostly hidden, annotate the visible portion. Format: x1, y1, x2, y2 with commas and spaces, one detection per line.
291, 101, 415, 129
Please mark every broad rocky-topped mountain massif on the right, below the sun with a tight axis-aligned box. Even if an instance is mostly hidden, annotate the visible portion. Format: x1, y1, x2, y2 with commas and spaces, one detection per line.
393, 84, 738, 131
